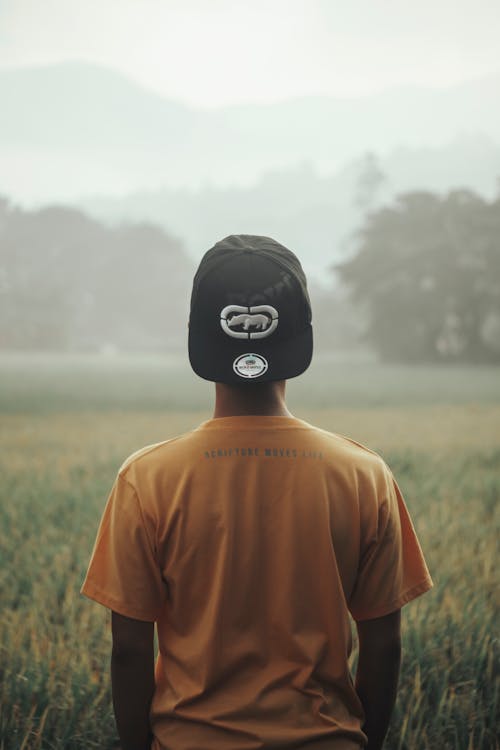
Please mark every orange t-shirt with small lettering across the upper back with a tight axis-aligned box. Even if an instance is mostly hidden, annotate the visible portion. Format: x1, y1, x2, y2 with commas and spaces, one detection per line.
82, 416, 432, 750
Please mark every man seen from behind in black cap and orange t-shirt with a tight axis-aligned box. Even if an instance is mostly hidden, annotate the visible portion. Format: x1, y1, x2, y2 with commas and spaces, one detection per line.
82, 235, 432, 750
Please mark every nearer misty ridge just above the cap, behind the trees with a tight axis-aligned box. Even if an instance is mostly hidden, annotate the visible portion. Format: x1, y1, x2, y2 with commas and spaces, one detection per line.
81, 137, 500, 282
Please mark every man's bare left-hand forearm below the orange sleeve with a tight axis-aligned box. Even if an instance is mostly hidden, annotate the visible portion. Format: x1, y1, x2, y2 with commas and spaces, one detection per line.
111, 612, 155, 750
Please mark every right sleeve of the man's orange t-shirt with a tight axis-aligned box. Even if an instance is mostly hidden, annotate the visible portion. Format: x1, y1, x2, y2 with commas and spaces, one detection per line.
349, 465, 433, 621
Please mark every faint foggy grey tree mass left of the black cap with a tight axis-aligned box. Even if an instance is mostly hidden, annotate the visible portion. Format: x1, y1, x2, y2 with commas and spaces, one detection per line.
0, 200, 192, 351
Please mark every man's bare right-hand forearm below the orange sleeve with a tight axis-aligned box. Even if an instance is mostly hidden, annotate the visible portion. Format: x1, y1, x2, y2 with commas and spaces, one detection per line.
356, 610, 401, 750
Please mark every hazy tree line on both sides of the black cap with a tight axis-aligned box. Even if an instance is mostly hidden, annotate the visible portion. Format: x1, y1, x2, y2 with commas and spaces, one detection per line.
0, 190, 500, 362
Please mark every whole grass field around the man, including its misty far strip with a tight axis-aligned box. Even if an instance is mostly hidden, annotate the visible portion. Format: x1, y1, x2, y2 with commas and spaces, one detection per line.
0, 355, 500, 750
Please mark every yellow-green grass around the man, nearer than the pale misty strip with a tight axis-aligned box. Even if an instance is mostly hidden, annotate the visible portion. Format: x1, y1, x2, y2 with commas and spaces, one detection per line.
0, 356, 500, 750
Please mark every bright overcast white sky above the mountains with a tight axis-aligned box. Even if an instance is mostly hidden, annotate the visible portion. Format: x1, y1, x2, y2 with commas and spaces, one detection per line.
0, 0, 500, 106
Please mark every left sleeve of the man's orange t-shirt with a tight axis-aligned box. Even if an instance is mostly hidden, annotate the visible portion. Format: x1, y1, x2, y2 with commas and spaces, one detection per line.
81, 474, 167, 622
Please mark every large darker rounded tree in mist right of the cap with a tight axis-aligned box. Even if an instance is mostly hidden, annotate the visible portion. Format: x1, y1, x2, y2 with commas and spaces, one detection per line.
334, 190, 500, 362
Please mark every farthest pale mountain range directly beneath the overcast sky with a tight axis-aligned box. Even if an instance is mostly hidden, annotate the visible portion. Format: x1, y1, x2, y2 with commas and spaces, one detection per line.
0, 63, 500, 201
